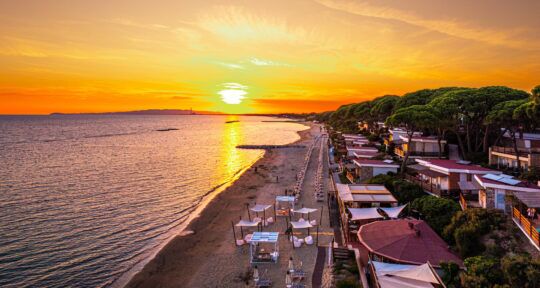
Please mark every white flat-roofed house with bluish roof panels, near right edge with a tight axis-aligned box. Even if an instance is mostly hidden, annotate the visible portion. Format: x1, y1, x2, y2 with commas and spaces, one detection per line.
474, 174, 540, 212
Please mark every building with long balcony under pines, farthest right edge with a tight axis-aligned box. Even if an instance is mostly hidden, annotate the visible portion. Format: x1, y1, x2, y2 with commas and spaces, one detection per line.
489, 133, 540, 171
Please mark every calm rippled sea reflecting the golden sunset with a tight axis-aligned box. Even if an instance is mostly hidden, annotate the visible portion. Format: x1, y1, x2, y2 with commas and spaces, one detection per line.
0, 116, 305, 287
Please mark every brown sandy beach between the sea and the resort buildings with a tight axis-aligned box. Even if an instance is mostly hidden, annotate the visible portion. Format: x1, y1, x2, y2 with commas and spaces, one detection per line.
126, 125, 333, 287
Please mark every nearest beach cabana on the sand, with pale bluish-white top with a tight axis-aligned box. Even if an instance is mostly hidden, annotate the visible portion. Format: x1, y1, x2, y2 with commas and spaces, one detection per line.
249, 232, 279, 263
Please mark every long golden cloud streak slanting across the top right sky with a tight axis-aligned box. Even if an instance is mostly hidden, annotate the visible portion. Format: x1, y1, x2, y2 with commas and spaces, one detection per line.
315, 0, 540, 49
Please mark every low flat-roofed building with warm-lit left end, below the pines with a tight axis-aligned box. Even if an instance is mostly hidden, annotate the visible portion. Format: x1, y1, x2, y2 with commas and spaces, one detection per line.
394, 135, 446, 158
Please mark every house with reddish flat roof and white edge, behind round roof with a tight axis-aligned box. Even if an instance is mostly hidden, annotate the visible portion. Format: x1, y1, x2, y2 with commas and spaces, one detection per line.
407, 159, 501, 196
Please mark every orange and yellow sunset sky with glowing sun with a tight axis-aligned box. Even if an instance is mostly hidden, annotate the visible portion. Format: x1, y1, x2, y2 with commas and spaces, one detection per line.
0, 0, 540, 114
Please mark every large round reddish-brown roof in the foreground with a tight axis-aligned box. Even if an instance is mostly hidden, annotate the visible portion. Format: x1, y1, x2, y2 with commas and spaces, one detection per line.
358, 220, 463, 267
